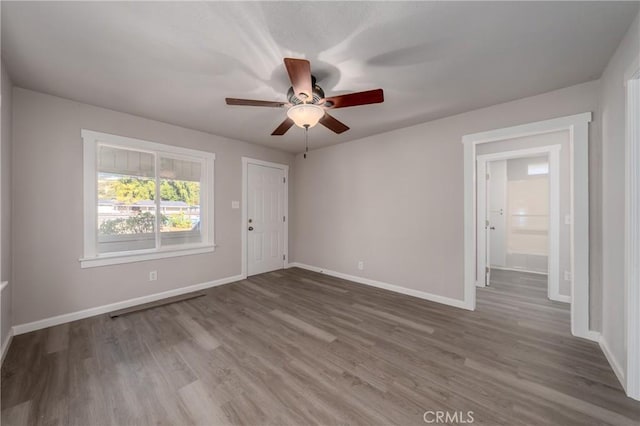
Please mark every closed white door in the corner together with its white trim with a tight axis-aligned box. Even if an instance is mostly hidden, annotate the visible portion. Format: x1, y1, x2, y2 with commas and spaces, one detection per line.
242, 157, 289, 276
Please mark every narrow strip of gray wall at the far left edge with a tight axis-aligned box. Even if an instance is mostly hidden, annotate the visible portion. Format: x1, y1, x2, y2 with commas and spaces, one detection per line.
0, 62, 13, 350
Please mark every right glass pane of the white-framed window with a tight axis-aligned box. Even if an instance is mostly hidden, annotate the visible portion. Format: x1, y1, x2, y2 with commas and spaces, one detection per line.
159, 157, 202, 245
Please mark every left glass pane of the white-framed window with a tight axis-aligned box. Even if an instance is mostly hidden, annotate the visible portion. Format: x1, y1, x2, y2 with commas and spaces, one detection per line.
97, 146, 156, 253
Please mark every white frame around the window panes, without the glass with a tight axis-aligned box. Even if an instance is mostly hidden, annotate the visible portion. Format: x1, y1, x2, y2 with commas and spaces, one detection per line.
79, 129, 216, 268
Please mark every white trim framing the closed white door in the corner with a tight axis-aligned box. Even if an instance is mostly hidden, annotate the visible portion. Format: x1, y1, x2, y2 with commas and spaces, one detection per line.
240, 157, 290, 278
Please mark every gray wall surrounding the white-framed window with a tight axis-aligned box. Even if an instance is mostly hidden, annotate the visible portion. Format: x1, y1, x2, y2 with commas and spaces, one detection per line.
12, 88, 293, 324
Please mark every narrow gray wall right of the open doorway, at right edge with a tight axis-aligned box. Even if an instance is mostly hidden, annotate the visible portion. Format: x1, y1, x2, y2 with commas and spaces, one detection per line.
601, 11, 640, 380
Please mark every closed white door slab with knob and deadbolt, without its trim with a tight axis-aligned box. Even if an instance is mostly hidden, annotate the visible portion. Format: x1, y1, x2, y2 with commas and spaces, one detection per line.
246, 164, 285, 275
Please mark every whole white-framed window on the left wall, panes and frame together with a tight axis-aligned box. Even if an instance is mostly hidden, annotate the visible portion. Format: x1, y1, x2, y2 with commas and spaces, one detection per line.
81, 130, 215, 268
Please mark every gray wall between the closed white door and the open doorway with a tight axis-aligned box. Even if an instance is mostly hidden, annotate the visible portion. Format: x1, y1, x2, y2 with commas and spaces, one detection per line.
293, 81, 600, 310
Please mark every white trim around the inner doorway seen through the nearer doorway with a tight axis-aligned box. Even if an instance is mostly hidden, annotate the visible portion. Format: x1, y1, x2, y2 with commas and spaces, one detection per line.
476, 145, 560, 303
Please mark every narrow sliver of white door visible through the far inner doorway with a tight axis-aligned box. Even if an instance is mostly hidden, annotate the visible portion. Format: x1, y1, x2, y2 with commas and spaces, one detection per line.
487, 160, 507, 267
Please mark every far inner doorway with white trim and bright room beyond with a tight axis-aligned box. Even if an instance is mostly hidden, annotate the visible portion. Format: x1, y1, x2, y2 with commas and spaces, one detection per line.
476, 148, 573, 303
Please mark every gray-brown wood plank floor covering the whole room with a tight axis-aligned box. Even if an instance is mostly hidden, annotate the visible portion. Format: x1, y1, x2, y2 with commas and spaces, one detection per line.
0, 268, 640, 426
